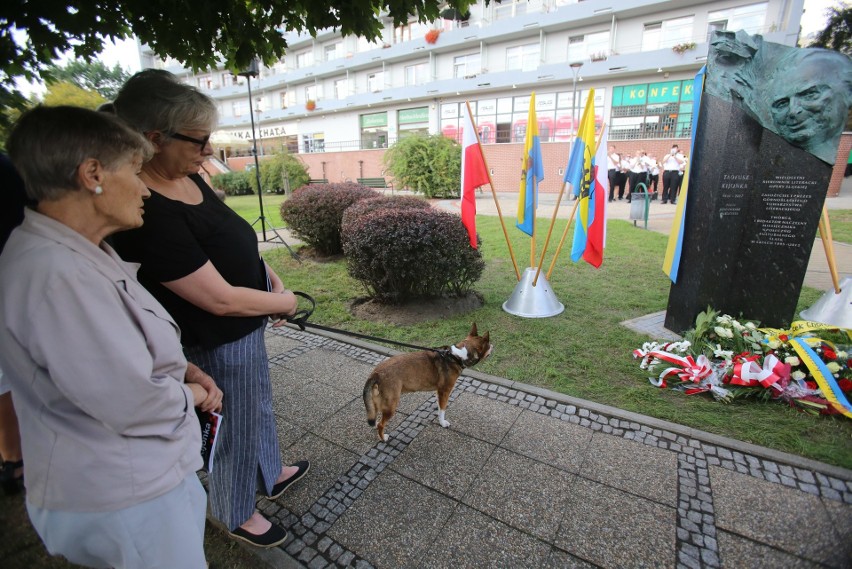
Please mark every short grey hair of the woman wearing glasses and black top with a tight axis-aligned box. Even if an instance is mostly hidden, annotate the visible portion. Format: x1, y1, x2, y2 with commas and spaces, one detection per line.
113, 69, 218, 135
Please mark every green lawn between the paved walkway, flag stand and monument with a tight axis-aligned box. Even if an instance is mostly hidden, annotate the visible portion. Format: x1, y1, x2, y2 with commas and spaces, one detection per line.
264, 216, 852, 468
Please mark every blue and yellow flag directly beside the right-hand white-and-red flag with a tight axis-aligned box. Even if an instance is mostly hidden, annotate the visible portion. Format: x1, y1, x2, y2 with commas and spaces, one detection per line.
564, 89, 596, 263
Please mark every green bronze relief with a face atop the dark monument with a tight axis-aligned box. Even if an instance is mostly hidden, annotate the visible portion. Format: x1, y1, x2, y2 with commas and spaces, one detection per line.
704, 31, 852, 164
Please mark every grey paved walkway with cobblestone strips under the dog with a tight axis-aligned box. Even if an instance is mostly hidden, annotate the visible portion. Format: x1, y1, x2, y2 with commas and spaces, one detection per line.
221, 327, 852, 569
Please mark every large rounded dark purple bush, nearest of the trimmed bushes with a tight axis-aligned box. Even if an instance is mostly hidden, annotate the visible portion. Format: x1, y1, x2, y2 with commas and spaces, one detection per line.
343, 208, 485, 303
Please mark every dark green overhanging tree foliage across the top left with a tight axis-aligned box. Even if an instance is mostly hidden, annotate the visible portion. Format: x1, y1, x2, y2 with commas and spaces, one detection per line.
0, 0, 480, 124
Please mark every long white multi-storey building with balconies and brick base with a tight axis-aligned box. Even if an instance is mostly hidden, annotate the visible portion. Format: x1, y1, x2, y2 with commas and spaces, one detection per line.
142, 0, 804, 191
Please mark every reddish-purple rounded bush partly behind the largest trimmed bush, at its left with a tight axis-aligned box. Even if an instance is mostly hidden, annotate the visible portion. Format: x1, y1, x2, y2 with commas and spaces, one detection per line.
281, 183, 380, 255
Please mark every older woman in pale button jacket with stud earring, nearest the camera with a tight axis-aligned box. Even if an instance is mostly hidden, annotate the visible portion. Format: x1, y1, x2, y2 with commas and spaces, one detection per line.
0, 107, 222, 569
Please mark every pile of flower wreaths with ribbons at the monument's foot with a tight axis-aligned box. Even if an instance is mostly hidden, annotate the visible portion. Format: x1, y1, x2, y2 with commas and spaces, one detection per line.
633, 308, 852, 418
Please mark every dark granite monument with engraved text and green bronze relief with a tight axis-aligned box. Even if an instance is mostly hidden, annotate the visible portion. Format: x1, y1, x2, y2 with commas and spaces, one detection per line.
665, 32, 852, 332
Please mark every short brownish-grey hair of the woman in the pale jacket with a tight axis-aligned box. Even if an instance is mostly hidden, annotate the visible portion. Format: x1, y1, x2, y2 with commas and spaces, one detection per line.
7, 105, 153, 201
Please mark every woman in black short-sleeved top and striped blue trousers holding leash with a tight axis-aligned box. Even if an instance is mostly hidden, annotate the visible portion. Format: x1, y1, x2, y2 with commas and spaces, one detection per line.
114, 69, 310, 547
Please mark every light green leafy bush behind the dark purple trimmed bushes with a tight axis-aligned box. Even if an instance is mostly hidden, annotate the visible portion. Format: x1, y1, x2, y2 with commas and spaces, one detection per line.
384, 134, 461, 198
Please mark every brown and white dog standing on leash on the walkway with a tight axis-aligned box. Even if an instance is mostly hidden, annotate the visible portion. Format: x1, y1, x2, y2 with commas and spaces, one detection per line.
364, 323, 493, 441
